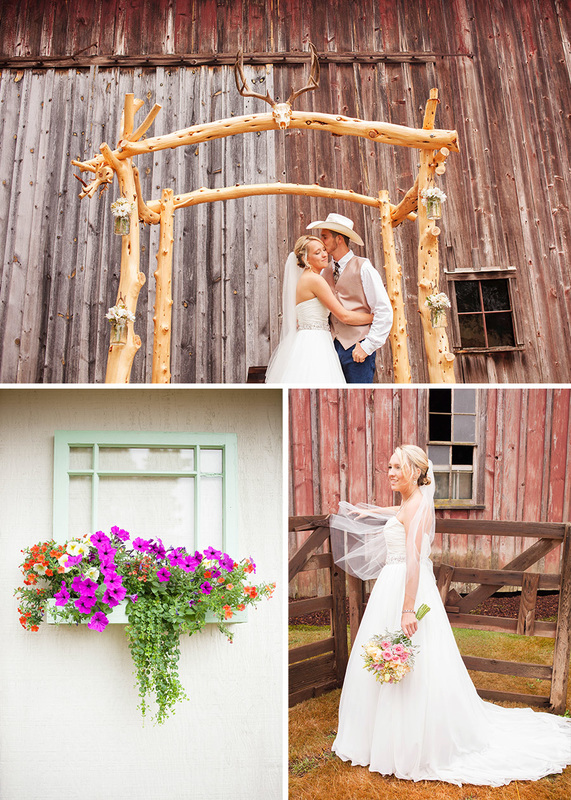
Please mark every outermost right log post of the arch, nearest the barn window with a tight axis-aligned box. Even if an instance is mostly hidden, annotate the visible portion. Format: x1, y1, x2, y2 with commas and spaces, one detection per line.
418, 89, 456, 383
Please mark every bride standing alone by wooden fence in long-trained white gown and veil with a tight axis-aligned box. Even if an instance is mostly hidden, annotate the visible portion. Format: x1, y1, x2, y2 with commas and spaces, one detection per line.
331, 445, 571, 786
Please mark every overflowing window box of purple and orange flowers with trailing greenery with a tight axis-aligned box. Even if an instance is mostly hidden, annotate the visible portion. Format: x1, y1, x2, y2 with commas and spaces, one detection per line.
15, 526, 275, 723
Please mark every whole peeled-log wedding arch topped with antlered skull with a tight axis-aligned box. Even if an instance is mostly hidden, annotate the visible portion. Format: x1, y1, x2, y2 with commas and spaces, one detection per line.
72, 45, 459, 383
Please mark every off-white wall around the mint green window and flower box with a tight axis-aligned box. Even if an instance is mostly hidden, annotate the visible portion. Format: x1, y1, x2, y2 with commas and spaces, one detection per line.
0, 387, 285, 800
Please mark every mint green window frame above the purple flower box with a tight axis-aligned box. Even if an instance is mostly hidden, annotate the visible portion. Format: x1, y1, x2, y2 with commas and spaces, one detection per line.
53, 431, 238, 554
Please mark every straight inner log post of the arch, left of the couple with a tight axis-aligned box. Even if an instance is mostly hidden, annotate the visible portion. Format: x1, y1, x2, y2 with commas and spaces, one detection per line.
151, 189, 174, 383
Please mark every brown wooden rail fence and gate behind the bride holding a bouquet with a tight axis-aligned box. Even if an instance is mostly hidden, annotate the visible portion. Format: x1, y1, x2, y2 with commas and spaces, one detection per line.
290, 516, 571, 714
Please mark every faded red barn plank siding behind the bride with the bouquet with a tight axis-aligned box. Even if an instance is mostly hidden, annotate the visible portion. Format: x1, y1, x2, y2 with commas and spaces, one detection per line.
289, 387, 571, 595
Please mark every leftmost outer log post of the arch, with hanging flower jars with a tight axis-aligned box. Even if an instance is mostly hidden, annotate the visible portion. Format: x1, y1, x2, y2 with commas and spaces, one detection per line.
101, 143, 145, 383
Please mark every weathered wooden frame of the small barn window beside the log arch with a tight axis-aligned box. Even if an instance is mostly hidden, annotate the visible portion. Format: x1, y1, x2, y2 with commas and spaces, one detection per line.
444, 266, 524, 355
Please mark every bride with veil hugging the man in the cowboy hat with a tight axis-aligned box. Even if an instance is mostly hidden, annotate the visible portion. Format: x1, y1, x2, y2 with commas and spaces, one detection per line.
266, 236, 373, 386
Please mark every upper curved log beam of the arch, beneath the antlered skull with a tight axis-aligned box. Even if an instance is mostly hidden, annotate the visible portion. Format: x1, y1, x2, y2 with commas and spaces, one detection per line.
76, 111, 459, 176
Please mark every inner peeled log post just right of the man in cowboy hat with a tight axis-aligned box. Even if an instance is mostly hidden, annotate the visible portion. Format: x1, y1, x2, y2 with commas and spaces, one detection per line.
379, 189, 412, 383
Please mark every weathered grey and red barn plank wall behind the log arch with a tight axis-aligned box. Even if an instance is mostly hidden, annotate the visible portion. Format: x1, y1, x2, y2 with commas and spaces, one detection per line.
0, 0, 571, 382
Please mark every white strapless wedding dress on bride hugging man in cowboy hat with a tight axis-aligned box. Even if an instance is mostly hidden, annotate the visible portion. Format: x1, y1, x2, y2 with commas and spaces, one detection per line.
266, 297, 346, 386
